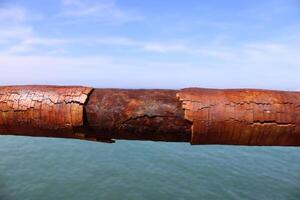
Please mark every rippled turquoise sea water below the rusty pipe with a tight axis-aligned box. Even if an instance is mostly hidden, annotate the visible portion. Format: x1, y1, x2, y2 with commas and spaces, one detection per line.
0, 136, 300, 200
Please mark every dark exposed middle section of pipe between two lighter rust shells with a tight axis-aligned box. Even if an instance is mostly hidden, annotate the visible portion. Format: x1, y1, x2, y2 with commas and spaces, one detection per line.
86, 89, 191, 142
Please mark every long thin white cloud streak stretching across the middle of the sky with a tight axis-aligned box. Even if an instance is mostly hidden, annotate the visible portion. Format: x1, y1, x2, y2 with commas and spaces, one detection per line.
0, 29, 300, 67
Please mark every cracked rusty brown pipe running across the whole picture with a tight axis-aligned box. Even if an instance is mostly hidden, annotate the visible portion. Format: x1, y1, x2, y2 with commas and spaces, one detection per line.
0, 86, 300, 146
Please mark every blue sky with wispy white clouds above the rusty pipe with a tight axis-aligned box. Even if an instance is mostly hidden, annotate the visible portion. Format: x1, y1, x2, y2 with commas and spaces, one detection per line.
0, 0, 300, 90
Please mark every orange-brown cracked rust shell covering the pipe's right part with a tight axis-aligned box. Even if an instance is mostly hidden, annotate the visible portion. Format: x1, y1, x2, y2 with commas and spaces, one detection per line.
177, 88, 300, 146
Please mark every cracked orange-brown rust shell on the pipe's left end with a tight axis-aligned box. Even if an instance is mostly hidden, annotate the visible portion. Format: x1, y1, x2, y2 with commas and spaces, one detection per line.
0, 86, 92, 138
